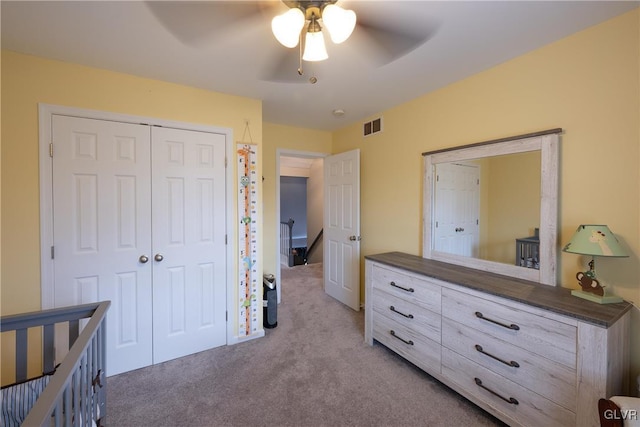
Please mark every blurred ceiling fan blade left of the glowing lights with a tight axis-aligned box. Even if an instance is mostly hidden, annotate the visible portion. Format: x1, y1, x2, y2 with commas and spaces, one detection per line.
145, 0, 286, 46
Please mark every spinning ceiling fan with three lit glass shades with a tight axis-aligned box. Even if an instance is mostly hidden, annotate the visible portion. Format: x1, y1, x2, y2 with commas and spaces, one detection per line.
146, 0, 437, 83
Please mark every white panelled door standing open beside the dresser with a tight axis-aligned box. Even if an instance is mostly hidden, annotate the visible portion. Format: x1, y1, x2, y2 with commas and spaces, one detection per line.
324, 150, 360, 311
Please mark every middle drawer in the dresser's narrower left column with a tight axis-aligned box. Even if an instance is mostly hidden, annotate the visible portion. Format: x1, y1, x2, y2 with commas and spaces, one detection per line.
373, 289, 442, 343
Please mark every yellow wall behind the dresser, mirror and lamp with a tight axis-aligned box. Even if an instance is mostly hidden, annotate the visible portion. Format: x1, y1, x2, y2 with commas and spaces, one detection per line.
333, 9, 640, 392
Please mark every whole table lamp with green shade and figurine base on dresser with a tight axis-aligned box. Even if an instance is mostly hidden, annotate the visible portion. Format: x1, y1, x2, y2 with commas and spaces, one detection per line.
562, 224, 629, 304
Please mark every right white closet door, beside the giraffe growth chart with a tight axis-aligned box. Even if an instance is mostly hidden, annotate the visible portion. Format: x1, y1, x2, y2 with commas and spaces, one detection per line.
152, 127, 226, 363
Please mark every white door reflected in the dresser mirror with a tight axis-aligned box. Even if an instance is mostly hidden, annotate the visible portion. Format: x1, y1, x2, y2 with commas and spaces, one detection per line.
433, 163, 480, 257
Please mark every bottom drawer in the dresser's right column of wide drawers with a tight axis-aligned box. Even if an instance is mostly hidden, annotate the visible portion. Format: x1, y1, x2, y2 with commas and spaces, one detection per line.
442, 348, 576, 427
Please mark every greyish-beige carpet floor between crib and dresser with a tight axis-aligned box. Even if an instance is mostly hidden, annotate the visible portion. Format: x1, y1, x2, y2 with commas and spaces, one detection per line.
107, 264, 503, 427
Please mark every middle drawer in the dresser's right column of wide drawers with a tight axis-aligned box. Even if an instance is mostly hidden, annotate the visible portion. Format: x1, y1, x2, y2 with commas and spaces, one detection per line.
442, 318, 576, 412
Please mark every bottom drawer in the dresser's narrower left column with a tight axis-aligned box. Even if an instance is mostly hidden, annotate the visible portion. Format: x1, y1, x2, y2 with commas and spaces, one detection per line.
373, 315, 441, 373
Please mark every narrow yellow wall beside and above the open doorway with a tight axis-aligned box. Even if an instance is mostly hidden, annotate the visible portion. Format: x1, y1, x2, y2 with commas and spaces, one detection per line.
262, 123, 331, 274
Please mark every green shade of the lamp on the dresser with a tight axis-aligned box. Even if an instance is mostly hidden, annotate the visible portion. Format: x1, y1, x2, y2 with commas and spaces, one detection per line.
562, 224, 629, 257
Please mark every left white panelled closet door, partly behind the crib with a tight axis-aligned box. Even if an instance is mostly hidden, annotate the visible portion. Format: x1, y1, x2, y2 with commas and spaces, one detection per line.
52, 116, 152, 375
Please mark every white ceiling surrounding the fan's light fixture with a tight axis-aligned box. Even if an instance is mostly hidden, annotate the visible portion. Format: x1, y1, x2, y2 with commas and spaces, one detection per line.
0, 0, 639, 130
